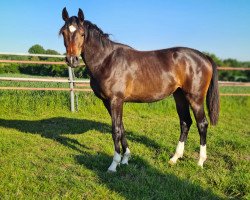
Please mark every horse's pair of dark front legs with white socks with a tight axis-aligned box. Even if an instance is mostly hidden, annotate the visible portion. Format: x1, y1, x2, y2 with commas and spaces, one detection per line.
108, 97, 130, 172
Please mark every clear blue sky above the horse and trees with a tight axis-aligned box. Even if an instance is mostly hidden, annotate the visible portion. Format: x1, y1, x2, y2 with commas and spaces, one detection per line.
0, 0, 250, 61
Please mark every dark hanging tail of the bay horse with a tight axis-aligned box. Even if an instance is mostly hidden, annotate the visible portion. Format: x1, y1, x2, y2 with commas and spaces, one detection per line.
206, 56, 220, 125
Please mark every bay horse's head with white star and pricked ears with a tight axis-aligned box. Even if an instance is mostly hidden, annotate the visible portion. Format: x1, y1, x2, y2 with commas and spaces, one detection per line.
60, 8, 85, 67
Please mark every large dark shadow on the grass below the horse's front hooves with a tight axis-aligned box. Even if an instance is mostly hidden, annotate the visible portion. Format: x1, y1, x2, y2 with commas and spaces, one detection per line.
76, 152, 220, 200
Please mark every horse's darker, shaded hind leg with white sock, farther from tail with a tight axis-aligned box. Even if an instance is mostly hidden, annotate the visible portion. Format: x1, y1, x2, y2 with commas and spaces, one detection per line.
169, 89, 192, 164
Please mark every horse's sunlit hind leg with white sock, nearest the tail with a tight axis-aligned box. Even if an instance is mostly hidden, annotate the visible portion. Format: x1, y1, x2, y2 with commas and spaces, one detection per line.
190, 98, 208, 167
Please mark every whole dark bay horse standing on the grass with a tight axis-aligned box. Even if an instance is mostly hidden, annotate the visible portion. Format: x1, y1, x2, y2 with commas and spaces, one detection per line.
59, 8, 219, 172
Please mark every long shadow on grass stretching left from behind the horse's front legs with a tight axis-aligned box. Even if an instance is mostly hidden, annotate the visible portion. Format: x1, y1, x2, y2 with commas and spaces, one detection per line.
0, 117, 166, 153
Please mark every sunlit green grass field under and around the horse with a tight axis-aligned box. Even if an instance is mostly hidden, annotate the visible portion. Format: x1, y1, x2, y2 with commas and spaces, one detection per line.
0, 85, 250, 200
